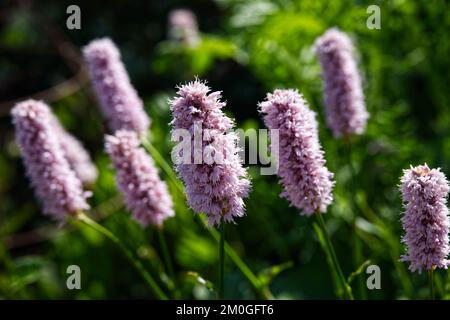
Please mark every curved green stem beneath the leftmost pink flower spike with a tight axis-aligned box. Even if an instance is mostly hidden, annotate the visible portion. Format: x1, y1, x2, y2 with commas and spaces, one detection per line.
76, 212, 168, 300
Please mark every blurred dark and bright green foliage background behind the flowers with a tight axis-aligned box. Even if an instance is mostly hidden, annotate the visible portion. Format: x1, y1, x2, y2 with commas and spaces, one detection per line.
0, 0, 450, 299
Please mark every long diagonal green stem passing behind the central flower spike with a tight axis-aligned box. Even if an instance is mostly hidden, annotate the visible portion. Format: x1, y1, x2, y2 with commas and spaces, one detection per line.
141, 137, 274, 300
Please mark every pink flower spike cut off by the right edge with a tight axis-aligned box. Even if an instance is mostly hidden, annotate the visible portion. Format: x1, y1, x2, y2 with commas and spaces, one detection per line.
400, 164, 450, 273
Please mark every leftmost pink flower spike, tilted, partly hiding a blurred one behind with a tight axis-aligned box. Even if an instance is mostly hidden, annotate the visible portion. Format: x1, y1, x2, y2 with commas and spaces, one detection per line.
12, 100, 89, 220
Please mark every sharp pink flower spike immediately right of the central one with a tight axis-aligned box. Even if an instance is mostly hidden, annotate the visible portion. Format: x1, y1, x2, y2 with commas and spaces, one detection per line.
259, 90, 334, 215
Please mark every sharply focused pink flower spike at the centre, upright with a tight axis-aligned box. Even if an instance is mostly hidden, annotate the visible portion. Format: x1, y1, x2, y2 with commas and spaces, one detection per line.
170, 80, 250, 225
